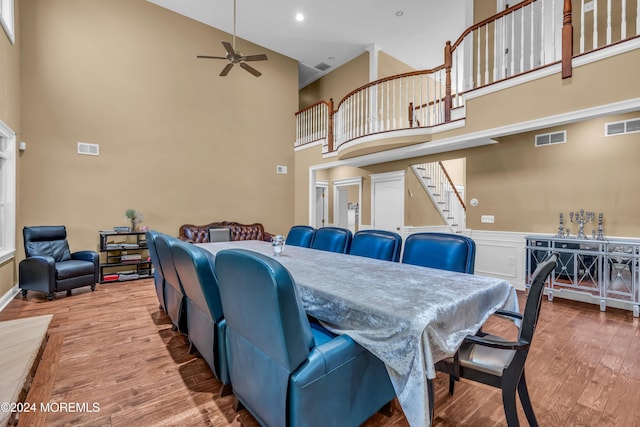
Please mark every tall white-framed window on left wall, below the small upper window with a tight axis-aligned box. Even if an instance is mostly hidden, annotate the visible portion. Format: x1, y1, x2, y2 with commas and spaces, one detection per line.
0, 120, 16, 264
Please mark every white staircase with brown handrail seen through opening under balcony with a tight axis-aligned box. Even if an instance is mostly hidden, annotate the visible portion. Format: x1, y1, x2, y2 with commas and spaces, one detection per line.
411, 162, 467, 233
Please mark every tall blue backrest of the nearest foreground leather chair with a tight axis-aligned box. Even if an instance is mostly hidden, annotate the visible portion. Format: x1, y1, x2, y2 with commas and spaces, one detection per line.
215, 249, 314, 426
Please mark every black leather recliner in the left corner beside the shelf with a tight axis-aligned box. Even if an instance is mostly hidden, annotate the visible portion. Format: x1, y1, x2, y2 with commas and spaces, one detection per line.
18, 225, 100, 300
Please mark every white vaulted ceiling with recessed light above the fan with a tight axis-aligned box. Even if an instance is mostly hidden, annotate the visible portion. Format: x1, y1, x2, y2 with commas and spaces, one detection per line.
148, 0, 472, 87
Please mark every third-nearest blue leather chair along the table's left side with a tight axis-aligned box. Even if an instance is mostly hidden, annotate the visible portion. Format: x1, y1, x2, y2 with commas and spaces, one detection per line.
155, 233, 187, 334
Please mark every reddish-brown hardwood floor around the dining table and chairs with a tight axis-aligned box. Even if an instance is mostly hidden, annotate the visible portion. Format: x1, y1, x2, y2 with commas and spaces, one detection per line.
0, 280, 640, 427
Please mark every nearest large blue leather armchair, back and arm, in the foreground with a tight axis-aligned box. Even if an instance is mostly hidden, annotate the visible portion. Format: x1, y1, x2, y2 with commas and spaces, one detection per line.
215, 249, 395, 427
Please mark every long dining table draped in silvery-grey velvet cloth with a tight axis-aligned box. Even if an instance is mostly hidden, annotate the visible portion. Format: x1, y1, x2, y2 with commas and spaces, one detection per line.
198, 240, 518, 427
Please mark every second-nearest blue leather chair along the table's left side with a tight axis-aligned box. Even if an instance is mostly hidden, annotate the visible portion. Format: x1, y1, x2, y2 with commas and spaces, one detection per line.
171, 241, 230, 395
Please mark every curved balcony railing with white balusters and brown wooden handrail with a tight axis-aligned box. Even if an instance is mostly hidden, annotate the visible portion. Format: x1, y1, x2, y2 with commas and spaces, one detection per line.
295, 0, 640, 152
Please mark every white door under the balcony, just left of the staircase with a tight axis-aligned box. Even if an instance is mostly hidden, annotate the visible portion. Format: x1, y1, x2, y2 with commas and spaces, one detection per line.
371, 171, 404, 233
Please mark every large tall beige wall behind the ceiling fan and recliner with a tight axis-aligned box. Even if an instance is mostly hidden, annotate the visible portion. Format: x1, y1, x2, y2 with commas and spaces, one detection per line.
18, 0, 298, 258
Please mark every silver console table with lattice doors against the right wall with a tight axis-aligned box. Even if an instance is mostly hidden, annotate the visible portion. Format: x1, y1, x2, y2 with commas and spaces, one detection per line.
525, 235, 640, 317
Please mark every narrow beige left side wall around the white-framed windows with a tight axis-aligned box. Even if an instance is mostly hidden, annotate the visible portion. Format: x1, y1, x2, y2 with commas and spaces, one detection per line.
0, 0, 21, 297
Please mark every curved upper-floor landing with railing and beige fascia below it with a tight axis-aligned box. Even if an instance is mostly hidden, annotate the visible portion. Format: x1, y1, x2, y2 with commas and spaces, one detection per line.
295, 0, 640, 161
